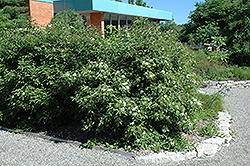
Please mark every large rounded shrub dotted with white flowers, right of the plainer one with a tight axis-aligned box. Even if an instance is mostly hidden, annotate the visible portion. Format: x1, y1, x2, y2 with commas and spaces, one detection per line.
73, 20, 203, 151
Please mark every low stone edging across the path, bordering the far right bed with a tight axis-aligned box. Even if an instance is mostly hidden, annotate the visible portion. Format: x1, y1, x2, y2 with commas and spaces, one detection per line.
202, 80, 250, 89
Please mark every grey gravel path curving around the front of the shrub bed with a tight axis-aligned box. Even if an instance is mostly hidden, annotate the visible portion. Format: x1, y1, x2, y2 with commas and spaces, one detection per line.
0, 88, 250, 166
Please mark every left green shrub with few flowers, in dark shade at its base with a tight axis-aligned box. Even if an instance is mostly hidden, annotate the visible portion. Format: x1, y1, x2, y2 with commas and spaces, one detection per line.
0, 22, 102, 127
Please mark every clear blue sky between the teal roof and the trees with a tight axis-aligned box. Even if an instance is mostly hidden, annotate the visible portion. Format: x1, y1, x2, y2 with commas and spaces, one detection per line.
123, 0, 205, 24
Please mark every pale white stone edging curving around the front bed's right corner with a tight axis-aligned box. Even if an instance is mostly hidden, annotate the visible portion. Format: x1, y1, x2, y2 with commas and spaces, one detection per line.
136, 112, 232, 162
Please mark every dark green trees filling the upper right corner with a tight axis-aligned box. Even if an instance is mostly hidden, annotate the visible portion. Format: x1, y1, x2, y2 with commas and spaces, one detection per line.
180, 0, 250, 65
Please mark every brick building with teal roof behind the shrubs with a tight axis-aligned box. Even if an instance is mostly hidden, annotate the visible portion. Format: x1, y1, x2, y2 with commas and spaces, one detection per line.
29, 0, 172, 33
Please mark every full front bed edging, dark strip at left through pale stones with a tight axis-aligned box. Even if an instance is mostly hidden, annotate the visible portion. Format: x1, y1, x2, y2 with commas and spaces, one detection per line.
0, 112, 232, 162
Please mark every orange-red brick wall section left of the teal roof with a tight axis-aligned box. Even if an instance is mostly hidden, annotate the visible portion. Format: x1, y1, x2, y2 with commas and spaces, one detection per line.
29, 0, 54, 25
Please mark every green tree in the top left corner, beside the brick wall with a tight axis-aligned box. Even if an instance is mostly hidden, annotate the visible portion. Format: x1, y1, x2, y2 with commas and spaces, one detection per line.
0, 0, 30, 28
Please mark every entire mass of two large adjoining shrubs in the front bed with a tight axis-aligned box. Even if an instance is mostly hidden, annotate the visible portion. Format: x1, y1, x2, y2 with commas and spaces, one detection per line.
0, 16, 201, 151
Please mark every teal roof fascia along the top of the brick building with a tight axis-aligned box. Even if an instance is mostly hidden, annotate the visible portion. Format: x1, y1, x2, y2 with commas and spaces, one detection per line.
53, 0, 172, 20
